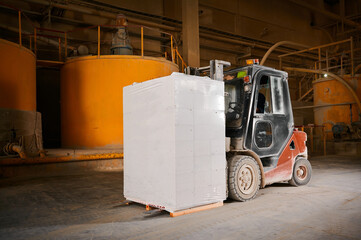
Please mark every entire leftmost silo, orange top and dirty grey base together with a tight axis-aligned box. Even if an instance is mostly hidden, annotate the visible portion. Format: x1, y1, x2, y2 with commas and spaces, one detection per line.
0, 39, 42, 157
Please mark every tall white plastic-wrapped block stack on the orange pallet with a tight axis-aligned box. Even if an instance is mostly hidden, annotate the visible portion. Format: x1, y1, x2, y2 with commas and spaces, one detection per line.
123, 73, 226, 212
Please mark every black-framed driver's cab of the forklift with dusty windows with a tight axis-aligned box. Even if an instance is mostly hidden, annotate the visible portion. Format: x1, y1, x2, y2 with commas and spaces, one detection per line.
224, 65, 293, 158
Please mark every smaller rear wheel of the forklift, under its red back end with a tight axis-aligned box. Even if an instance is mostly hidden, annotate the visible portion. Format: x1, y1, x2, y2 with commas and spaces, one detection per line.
289, 158, 312, 186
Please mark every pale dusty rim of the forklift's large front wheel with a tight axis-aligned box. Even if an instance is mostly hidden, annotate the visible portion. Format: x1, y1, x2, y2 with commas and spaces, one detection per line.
237, 164, 256, 194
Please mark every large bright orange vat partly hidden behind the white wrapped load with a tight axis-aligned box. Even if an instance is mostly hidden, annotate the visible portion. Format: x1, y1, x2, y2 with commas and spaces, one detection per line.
61, 55, 178, 148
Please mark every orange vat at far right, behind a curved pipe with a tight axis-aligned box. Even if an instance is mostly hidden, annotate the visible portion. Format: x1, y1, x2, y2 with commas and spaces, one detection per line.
313, 75, 361, 137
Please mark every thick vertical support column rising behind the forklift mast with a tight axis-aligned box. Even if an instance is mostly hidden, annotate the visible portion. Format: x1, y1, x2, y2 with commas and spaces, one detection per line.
182, 0, 200, 67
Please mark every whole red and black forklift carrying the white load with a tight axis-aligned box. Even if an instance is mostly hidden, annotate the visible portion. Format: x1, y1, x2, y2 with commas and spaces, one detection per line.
185, 59, 312, 201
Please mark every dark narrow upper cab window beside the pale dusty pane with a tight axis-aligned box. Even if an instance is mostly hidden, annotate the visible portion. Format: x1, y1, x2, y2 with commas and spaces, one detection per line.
256, 75, 272, 114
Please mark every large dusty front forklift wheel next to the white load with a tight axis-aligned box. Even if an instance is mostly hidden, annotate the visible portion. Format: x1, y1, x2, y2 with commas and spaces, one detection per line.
228, 155, 261, 202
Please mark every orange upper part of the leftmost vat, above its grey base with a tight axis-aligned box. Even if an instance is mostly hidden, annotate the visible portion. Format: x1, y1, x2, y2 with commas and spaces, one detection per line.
0, 39, 36, 111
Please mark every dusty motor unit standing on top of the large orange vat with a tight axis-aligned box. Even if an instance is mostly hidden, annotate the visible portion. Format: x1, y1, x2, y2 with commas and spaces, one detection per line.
110, 14, 133, 55
